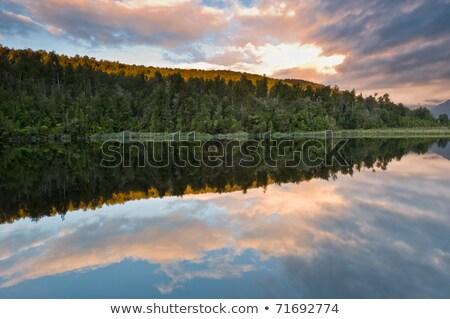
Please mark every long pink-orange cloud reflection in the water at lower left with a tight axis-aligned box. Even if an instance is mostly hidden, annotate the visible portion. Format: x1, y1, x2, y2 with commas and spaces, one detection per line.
0, 211, 231, 287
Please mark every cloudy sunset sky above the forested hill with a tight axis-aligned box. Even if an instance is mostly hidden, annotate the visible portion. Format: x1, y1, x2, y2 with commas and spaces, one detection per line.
0, 0, 450, 105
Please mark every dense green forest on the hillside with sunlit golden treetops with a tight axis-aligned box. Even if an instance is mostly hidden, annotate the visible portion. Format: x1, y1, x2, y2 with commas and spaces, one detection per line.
0, 46, 448, 136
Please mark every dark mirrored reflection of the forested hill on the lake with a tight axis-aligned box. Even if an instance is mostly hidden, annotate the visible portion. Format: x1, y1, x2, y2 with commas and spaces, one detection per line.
0, 139, 447, 224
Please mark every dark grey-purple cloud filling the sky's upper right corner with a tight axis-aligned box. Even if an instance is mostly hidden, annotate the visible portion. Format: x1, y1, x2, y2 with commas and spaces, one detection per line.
312, 0, 450, 87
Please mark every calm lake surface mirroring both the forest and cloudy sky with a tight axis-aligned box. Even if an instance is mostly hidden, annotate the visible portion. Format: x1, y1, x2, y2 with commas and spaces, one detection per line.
0, 139, 450, 298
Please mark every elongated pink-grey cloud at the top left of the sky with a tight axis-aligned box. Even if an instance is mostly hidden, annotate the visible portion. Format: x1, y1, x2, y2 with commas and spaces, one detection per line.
9, 0, 226, 47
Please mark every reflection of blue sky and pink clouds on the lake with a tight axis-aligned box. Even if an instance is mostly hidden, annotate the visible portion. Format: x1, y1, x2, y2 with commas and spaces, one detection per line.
0, 139, 450, 298
